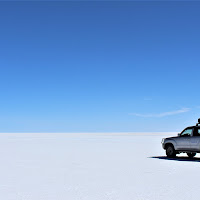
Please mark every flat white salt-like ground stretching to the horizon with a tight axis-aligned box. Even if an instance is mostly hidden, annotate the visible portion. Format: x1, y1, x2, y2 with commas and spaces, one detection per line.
0, 133, 200, 200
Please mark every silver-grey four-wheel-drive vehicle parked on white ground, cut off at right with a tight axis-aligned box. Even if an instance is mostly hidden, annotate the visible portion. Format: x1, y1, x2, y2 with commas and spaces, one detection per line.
161, 118, 200, 158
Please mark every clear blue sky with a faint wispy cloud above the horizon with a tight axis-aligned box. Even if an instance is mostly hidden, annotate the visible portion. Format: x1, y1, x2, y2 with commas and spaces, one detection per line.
0, 1, 200, 132
